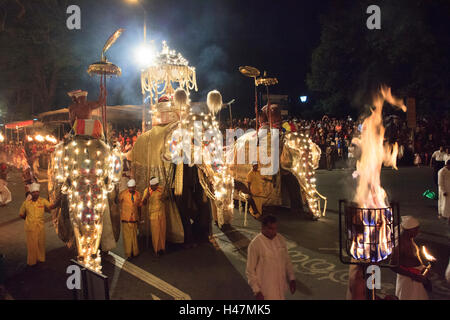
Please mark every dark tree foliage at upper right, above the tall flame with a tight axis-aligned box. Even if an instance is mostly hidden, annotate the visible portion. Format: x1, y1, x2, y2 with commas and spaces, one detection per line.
307, 0, 450, 115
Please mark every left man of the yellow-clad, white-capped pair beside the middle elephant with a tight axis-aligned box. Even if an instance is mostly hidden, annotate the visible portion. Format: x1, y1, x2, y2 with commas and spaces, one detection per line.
119, 179, 141, 259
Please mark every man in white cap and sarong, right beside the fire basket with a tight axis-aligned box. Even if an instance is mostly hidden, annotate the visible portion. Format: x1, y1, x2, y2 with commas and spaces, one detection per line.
392, 216, 431, 300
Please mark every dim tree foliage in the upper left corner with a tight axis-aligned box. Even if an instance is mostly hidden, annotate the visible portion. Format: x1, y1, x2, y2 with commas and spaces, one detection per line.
0, 0, 79, 119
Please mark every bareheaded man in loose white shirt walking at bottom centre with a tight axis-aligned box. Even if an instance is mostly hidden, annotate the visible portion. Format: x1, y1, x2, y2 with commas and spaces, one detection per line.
246, 215, 296, 300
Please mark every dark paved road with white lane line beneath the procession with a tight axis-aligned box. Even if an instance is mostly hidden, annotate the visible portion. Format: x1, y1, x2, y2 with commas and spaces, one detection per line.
0, 167, 450, 300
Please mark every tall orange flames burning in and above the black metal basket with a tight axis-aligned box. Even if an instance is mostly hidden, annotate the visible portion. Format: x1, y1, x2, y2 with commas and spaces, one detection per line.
350, 86, 406, 261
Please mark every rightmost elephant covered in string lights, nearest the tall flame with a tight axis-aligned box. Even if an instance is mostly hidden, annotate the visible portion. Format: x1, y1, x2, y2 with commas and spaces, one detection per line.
227, 126, 326, 219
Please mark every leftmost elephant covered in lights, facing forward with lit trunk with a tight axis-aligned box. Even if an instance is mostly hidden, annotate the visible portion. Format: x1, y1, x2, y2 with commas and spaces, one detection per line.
49, 135, 122, 272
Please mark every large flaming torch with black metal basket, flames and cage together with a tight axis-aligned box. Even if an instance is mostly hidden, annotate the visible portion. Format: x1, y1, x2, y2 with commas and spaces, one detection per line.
339, 86, 406, 296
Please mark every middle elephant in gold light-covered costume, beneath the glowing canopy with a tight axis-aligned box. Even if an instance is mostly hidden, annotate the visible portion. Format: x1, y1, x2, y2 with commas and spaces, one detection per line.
129, 89, 233, 234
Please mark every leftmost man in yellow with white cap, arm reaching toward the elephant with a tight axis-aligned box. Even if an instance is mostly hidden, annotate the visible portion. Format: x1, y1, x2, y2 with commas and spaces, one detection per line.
19, 183, 59, 266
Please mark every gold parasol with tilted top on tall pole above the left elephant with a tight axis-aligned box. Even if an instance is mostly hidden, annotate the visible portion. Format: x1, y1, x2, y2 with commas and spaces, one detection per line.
87, 28, 124, 139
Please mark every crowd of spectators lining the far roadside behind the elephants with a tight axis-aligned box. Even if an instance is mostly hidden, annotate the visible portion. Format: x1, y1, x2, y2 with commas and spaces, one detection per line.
0, 116, 450, 174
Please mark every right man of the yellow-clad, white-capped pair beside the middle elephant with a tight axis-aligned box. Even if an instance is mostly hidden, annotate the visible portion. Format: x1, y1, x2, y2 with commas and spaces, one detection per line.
142, 177, 166, 256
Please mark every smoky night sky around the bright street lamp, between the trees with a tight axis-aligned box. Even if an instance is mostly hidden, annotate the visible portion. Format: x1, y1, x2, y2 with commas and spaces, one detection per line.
51, 0, 329, 116
